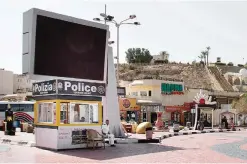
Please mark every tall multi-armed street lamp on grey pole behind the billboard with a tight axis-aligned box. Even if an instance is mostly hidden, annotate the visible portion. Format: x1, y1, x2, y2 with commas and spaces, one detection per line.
93, 13, 141, 85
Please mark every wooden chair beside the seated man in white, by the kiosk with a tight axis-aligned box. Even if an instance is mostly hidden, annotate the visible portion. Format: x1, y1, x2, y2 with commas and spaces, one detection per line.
87, 129, 105, 149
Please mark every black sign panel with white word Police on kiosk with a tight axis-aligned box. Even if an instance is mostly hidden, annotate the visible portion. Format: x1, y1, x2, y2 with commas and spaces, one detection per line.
57, 80, 105, 96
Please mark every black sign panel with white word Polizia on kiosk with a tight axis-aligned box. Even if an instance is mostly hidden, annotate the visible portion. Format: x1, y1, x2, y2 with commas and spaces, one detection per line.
33, 80, 57, 96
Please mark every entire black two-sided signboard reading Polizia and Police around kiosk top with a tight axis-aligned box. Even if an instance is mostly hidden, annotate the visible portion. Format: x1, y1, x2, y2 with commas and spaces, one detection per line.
33, 79, 106, 96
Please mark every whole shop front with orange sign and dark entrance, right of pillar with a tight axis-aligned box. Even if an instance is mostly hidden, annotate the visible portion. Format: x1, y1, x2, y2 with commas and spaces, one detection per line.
119, 98, 141, 123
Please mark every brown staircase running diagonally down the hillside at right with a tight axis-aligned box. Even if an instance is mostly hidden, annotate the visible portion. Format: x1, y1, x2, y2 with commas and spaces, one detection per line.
208, 67, 234, 92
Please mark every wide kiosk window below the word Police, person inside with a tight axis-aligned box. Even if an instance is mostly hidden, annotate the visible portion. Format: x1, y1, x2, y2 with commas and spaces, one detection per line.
70, 103, 99, 124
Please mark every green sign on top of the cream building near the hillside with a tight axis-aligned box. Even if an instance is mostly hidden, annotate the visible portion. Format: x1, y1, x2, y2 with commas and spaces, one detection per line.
161, 83, 184, 95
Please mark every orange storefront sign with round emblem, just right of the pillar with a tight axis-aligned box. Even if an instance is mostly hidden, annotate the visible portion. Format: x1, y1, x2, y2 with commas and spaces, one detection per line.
119, 98, 141, 111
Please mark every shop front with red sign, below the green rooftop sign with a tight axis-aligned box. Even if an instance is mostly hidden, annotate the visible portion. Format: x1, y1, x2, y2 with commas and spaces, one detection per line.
165, 103, 192, 125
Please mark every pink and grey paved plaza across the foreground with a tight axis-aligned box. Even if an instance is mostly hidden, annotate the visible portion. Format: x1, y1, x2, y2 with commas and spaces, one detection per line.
0, 131, 247, 163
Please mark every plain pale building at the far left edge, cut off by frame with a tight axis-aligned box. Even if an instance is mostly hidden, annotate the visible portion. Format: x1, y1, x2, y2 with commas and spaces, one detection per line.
0, 69, 13, 96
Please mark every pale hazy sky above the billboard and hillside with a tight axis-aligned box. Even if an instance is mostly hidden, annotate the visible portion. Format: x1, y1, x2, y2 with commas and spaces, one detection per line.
0, 0, 247, 73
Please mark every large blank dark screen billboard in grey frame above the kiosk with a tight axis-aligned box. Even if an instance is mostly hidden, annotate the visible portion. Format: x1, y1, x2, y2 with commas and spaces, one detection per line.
23, 9, 109, 82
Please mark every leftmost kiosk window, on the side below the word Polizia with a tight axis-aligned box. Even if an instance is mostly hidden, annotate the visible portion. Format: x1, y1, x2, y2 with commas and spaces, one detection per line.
38, 102, 56, 123
